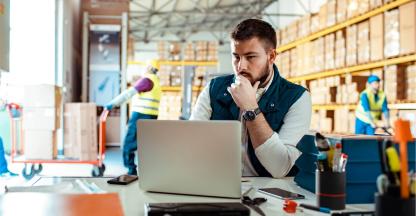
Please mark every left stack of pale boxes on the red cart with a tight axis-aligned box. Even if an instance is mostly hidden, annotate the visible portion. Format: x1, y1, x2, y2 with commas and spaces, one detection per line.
22, 85, 62, 160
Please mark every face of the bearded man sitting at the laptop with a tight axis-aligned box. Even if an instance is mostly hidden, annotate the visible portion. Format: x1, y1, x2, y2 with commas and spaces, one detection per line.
231, 37, 276, 86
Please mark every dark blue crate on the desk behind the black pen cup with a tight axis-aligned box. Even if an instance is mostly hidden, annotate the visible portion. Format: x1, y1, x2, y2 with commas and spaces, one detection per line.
295, 135, 416, 204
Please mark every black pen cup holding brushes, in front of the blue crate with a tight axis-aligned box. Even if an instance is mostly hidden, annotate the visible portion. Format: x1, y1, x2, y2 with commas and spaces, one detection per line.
315, 170, 346, 210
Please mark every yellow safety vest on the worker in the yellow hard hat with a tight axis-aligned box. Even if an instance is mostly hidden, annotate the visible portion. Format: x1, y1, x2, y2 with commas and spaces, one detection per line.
132, 73, 162, 116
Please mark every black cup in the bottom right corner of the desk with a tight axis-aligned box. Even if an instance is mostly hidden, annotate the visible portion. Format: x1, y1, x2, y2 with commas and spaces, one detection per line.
374, 193, 415, 216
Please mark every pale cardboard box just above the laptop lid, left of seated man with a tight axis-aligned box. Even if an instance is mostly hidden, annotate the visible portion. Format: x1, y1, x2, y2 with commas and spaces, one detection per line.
158, 92, 182, 120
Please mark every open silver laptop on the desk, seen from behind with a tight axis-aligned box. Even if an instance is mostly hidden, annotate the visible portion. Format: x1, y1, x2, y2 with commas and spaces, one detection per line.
137, 120, 241, 198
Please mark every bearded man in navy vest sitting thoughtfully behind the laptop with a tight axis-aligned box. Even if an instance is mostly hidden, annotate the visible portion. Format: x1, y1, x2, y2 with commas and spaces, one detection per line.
190, 19, 312, 178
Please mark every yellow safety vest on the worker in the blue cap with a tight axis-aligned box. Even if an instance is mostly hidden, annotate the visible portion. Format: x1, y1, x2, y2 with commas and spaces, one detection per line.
355, 88, 386, 124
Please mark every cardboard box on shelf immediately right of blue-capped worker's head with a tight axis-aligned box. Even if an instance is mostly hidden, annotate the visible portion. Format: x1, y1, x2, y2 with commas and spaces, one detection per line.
384, 65, 406, 102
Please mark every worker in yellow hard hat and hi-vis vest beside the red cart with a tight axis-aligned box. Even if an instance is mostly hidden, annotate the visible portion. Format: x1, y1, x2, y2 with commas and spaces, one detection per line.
105, 61, 162, 175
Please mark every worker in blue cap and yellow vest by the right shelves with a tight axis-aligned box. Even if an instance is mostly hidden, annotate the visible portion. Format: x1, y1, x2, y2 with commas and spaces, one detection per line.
355, 75, 390, 135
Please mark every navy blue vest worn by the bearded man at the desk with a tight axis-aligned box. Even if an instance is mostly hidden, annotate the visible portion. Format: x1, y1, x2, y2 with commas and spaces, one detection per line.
209, 65, 306, 177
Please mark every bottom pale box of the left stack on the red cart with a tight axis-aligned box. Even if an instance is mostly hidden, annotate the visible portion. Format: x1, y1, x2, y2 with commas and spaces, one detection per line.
23, 130, 56, 160
